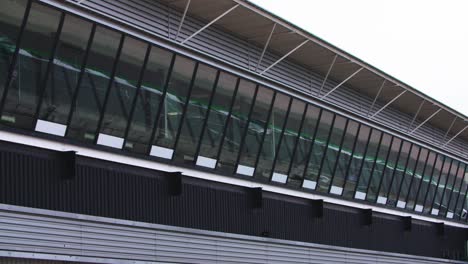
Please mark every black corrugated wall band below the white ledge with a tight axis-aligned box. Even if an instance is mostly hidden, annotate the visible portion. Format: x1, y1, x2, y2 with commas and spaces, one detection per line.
0, 139, 467, 258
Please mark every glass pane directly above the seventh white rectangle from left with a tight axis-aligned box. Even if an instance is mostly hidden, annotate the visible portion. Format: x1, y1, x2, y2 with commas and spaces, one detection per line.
304, 110, 335, 189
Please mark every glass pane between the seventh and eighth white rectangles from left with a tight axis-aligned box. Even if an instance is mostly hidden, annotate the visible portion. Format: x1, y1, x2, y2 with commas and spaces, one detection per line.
317, 115, 348, 193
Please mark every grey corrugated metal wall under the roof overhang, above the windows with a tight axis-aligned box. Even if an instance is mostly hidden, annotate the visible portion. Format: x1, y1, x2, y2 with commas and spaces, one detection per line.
61, 0, 468, 157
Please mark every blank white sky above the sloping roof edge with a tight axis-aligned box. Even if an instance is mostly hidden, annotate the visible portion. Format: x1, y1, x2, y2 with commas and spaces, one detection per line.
250, 0, 468, 116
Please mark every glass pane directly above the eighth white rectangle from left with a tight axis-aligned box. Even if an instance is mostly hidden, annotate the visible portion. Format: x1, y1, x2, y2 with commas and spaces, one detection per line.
332, 120, 359, 194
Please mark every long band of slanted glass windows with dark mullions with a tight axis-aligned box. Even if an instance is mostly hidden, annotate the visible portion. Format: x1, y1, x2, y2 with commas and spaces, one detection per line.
0, 0, 468, 221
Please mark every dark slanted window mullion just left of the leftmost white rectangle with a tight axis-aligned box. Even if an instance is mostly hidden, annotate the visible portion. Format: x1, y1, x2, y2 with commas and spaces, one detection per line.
33, 12, 66, 125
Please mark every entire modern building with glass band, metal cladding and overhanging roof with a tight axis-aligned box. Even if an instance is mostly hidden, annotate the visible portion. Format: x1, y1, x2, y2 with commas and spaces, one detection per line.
0, 0, 468, 263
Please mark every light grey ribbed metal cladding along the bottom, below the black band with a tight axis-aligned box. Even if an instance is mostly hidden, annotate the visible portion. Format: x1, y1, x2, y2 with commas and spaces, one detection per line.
0, 205, 465, 264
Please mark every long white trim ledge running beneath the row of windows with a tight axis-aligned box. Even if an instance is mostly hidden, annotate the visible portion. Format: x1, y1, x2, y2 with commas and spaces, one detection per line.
0, 130, 468, 228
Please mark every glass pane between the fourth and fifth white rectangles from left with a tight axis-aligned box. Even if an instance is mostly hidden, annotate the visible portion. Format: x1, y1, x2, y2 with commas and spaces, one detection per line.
217, 80, 256, 174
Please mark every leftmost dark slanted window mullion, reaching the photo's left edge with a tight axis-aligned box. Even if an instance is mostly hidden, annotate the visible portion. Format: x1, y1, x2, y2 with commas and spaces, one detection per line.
0, 0, 33, 116
